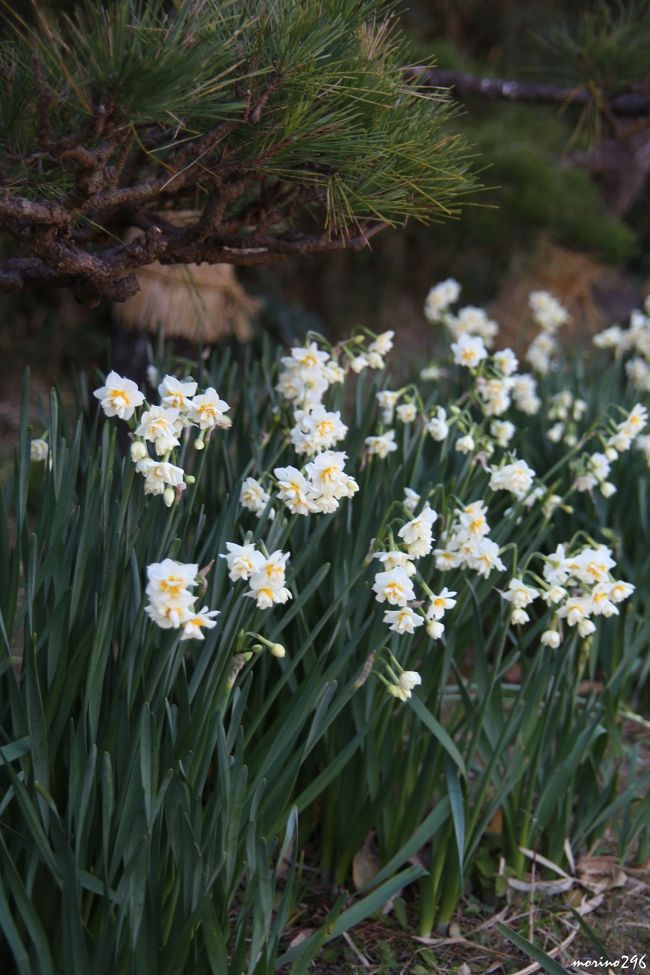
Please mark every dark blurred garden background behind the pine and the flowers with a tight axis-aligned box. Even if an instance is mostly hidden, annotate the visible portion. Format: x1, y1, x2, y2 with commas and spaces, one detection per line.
0, 0, 650, 432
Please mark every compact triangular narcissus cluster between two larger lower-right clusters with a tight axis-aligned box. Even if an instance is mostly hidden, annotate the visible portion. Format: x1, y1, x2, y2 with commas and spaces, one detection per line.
433, 500, 505, 578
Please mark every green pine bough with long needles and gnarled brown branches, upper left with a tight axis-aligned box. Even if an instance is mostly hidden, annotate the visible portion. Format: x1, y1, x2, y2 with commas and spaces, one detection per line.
0, 0, 475, 302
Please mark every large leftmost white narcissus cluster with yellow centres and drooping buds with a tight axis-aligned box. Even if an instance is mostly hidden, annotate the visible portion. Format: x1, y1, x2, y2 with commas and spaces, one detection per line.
93, 371, 232, 507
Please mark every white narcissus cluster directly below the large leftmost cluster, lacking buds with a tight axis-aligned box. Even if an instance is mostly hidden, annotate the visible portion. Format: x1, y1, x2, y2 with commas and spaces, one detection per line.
145, 559, 219, 640
